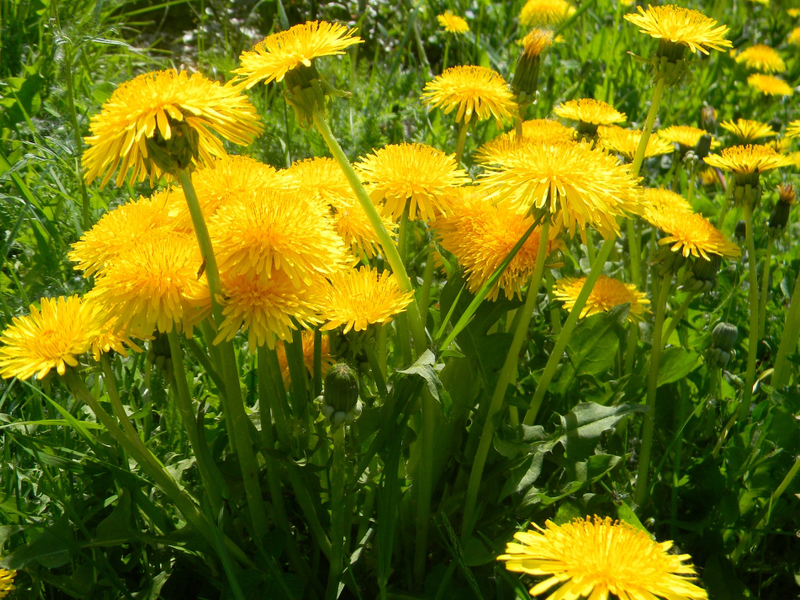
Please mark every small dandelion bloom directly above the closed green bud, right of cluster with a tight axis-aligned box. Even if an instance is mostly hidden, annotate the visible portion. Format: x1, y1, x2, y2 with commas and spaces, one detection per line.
320, 267, 414, 333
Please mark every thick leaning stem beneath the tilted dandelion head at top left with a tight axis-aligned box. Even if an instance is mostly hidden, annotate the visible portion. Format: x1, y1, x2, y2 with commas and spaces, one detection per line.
314, 108, 428, 356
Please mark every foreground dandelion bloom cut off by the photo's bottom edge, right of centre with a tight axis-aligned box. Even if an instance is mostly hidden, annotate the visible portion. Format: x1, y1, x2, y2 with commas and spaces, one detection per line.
497, 516, 708, 600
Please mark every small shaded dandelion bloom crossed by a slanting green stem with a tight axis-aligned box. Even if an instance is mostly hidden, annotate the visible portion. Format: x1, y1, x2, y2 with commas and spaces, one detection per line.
555, 275, 650, 322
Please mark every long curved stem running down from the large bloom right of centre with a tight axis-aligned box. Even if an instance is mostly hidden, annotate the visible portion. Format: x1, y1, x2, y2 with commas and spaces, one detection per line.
461, 219, 550, 544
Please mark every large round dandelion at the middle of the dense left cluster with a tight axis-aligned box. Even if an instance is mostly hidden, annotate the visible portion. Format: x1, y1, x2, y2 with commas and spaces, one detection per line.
208, 188, 347, 286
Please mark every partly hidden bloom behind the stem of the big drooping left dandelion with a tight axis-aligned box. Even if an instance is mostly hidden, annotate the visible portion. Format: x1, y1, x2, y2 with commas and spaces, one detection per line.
169, 155, 283, 232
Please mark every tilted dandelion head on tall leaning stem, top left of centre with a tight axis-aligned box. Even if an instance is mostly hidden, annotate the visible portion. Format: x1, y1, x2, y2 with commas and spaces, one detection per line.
233, 21, 364, 90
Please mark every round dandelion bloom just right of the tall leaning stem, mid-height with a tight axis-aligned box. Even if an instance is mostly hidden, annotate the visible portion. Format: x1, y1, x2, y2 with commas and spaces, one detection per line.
355, 143, 472, 221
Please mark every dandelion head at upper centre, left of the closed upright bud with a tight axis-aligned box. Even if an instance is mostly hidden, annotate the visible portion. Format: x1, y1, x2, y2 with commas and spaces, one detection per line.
422, 66, 517, 127
